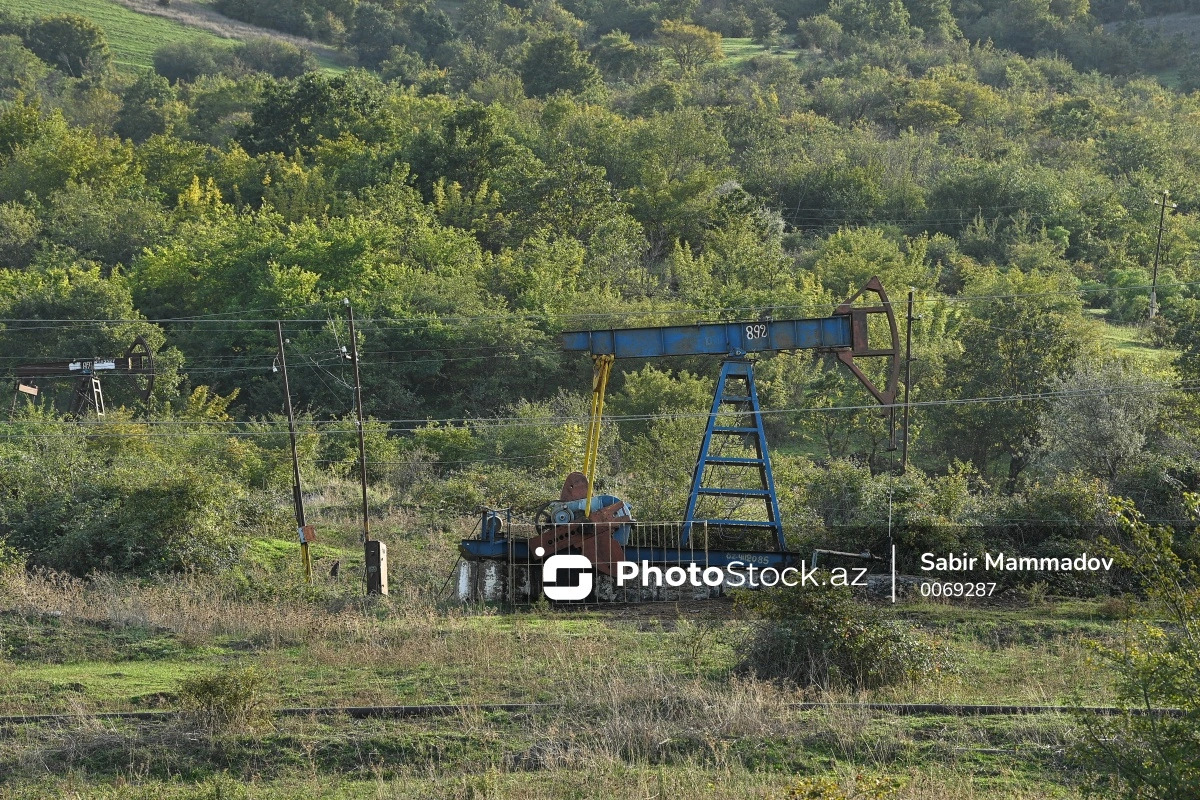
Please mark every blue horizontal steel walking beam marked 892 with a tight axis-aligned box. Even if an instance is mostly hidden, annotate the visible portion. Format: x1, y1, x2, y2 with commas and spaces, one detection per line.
563, 314, 853, 359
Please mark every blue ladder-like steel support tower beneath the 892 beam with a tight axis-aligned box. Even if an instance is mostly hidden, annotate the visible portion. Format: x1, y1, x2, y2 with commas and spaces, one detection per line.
679, 359, 787, 552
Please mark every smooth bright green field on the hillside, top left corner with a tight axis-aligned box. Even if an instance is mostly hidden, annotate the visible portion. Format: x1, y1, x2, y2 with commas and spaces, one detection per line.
0, 0, 228, 70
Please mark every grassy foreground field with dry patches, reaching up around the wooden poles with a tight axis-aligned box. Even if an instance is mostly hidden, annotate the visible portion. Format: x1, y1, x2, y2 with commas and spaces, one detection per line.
0, 493, 1118, 800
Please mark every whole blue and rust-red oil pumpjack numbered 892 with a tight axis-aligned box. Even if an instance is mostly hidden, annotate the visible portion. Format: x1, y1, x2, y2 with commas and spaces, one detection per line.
458, 277, 901, 602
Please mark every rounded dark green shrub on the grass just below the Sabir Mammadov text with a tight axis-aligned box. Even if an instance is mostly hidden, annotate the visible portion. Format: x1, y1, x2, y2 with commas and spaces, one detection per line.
738, 585, 949, 688
